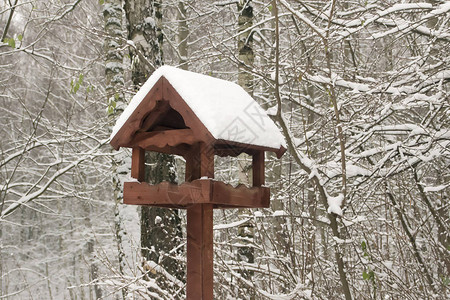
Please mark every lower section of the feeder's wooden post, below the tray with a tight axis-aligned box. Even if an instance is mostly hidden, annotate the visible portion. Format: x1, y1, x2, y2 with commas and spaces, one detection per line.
186, 204, 213, 300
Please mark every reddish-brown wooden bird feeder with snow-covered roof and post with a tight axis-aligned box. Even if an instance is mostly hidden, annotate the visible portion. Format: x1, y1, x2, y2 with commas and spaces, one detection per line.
110, 66, 286, 300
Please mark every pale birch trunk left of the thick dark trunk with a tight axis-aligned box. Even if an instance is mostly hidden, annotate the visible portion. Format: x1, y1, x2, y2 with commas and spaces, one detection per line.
103, 0, 139, 298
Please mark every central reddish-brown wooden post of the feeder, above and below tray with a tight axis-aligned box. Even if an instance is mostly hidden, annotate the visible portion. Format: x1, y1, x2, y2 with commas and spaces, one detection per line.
186, 144, 214, 300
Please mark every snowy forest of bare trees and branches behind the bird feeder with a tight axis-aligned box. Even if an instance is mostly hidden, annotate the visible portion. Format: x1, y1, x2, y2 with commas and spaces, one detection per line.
0, 0, 450, 300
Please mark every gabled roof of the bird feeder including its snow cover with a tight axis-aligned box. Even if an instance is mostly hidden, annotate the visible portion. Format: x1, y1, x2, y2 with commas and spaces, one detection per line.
111, 66, 286, 156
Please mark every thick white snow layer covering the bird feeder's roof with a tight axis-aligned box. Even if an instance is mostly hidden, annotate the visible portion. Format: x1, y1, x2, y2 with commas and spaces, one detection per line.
111, 66, 286, 149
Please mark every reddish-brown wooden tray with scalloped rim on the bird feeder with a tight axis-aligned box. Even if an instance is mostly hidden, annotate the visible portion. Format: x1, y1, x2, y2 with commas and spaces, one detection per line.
123, 179, 270, 208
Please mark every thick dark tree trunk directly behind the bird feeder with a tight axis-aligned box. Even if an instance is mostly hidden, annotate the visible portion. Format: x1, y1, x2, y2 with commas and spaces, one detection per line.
125, 0, 184, 289
